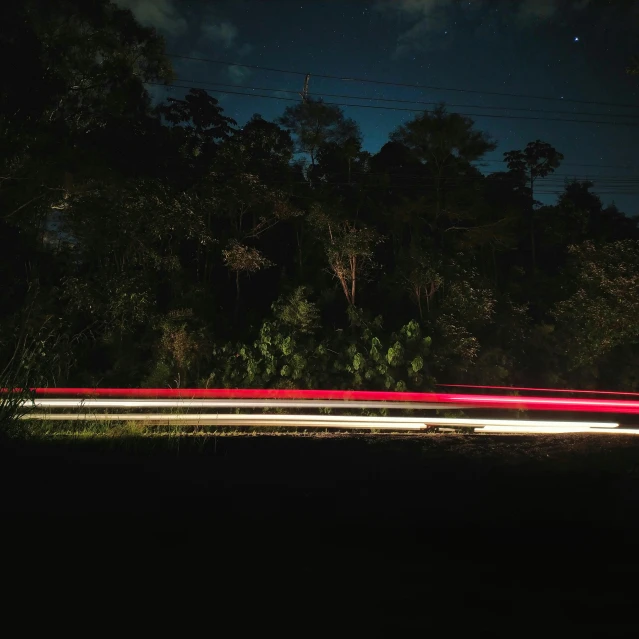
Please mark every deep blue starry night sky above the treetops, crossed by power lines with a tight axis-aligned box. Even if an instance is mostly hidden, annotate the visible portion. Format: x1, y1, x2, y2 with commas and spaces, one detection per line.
117, 0, 639, 215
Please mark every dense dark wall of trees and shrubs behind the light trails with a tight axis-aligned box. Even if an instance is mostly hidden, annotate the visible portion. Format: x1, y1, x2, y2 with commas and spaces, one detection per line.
0, 0, 639, 390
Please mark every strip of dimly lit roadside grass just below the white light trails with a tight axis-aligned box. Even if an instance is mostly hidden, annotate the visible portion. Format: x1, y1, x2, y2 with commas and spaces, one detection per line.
8, 420, 639, 479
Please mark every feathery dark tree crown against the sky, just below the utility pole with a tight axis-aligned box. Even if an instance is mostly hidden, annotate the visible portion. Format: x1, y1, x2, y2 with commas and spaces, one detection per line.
277, 98, 361, 167
